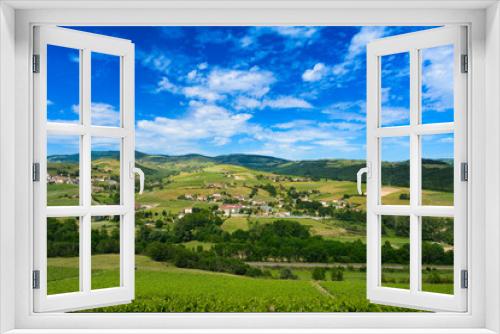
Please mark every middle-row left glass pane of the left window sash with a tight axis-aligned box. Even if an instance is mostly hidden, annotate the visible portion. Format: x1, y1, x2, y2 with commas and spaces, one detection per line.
47, 133, 80, 206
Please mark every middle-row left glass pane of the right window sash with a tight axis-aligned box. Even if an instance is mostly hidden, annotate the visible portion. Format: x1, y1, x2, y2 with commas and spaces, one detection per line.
381, 137, 410, 205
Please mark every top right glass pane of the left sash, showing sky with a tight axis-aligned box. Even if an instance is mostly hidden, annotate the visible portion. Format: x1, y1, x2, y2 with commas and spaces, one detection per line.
91, 52, 120, 127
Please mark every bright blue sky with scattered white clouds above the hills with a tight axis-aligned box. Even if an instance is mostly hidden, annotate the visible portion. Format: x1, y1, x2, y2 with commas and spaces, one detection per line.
47, 27, 453, 161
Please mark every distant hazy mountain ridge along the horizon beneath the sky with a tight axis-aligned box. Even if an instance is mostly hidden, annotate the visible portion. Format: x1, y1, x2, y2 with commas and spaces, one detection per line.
47, 151, 453, 191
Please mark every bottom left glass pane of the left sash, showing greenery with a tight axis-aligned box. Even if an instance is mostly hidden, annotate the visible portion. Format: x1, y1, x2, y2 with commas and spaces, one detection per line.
47, 217, 80, 295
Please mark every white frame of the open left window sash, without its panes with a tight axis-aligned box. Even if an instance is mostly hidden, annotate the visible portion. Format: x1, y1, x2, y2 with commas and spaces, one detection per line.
33, 26, 135, 312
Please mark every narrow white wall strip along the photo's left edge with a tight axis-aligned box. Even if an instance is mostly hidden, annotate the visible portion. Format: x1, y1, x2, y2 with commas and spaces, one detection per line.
0, 3, 15, 333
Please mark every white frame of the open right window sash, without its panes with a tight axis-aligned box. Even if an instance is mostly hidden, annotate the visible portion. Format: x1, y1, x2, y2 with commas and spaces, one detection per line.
366, 25, 470, 312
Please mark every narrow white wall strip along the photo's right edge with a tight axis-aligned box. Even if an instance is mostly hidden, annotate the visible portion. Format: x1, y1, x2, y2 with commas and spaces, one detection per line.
485, 3, 500, 333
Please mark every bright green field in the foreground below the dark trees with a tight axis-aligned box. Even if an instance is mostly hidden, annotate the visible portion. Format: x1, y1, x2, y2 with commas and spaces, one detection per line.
48, 254, 452, 312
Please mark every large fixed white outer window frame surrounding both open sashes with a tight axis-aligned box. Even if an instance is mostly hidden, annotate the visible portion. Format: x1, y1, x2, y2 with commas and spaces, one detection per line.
0, 1, 500, 333
